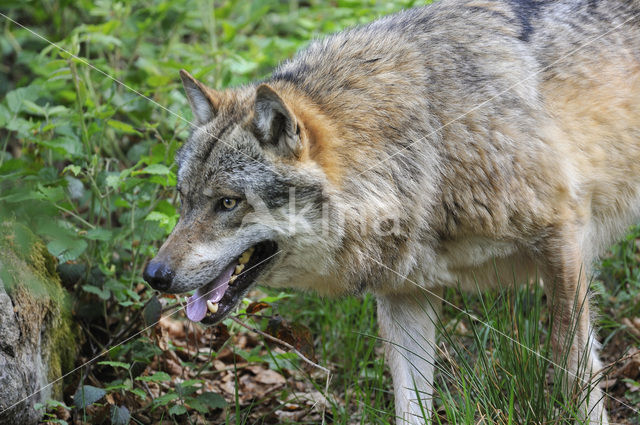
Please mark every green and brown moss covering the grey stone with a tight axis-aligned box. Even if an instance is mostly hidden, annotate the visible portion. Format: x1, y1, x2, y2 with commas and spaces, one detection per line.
0, 222, 81, 399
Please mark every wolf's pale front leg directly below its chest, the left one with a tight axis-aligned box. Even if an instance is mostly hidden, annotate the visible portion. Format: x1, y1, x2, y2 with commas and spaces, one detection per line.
378, 289, 442, 425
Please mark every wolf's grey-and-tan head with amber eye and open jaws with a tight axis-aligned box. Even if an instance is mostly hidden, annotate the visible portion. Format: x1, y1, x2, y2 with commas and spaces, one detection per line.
144, 71, 340, 323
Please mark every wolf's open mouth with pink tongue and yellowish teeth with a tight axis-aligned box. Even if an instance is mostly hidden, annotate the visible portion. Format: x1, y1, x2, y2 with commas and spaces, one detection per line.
182, 241, 278, 325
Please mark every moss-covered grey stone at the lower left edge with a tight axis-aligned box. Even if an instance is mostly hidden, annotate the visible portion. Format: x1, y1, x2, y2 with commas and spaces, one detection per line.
0, 222, 80, 425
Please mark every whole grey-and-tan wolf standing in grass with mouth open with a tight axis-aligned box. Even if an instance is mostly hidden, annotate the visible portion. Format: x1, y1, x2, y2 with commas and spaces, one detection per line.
144, 0, 640, 424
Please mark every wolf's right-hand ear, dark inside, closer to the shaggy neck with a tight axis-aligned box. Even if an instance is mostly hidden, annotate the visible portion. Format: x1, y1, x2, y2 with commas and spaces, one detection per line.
255, 84, 302, 156
